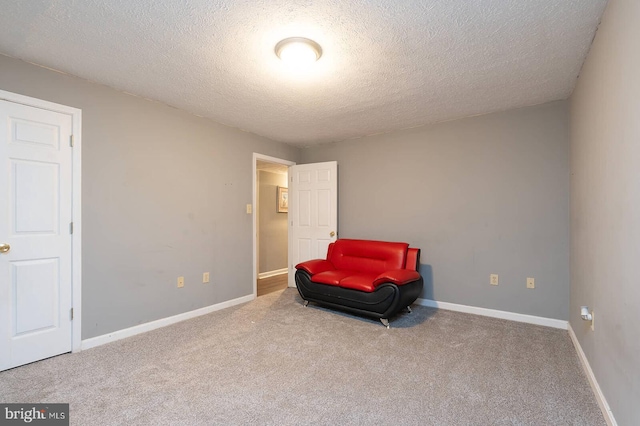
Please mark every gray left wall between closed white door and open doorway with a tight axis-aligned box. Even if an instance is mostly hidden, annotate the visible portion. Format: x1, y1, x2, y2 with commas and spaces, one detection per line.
0, 56, 298, 339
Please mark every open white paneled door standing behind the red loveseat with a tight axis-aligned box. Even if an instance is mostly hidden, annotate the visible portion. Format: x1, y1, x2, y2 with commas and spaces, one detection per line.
289, 161, 338, 287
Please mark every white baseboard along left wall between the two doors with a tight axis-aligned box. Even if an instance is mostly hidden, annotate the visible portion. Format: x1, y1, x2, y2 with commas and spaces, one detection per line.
81, 294, 255, 350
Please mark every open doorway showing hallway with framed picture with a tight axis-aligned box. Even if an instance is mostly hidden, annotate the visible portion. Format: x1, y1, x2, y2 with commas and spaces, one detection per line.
253, 154, 295, 297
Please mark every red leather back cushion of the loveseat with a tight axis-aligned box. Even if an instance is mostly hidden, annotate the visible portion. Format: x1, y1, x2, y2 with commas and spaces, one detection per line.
327, 239, 409, 274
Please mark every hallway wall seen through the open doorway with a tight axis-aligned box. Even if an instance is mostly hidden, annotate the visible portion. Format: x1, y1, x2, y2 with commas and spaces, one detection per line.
258, 171, 289, 272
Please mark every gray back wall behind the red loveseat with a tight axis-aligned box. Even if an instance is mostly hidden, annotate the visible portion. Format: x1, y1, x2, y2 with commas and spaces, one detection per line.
301, 102, 569, 319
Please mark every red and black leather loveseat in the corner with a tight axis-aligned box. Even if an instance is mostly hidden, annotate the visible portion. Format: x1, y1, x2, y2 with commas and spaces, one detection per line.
296, 239, 423, 328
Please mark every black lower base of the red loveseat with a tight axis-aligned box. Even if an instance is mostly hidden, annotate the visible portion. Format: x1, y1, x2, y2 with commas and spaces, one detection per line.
296, 269, 423, 323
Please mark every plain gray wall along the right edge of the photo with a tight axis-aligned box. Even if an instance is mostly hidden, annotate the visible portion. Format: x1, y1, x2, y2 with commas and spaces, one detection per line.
570, 0, 640, 425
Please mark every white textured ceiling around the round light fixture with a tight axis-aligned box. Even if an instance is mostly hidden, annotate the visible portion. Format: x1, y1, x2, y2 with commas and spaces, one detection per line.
0, 0, 606, 145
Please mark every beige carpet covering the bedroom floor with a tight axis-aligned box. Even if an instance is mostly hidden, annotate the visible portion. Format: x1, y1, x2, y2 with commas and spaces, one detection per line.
0, 289, 605, 425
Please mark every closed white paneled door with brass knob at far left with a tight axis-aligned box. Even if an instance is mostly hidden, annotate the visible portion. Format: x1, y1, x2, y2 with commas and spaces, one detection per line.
0, 101, 72, 371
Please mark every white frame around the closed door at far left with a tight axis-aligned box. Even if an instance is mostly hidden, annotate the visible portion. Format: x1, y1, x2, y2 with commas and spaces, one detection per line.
0, 90, 82, 352
